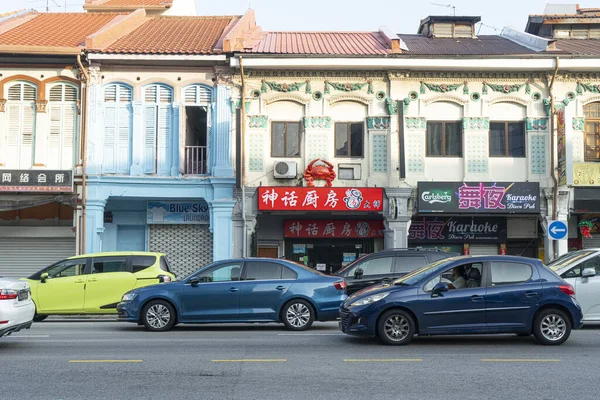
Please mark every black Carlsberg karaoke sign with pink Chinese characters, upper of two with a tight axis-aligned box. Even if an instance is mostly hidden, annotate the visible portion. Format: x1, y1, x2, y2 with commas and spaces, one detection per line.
418, 182, 540, 214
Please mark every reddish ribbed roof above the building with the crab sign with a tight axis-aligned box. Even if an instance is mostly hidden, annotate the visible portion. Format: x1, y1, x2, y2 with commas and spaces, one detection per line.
246, 32, 391, 56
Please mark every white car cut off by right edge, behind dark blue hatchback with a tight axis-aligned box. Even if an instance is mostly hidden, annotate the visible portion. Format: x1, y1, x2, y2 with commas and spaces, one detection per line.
548, 249, 600, 322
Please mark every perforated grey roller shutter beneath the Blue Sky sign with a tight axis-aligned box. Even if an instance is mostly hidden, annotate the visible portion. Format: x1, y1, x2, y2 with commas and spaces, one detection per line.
148, 225, 213, 278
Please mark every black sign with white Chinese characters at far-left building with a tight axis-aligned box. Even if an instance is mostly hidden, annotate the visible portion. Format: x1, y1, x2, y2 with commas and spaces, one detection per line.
0, 169, 73, 193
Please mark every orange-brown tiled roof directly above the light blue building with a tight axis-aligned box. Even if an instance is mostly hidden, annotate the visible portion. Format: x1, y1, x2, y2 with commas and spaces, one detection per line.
103, 17, 234, 54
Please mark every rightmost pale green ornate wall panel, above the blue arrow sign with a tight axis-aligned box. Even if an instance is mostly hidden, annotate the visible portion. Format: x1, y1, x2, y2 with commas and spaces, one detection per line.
526, 117, 550, 179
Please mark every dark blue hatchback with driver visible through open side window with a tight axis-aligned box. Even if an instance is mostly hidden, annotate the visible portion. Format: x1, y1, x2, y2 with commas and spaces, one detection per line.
340, 256, 582, 345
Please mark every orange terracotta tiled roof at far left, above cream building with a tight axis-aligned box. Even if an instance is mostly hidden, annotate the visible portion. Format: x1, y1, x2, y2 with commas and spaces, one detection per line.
0, 13, 121, 47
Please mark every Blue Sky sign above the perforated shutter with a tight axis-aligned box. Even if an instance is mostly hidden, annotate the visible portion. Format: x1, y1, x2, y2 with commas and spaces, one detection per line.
147, 200, 210, 224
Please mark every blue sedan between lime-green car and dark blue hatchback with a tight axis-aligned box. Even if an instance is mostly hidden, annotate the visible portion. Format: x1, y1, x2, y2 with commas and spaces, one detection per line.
117, 258, 347, 331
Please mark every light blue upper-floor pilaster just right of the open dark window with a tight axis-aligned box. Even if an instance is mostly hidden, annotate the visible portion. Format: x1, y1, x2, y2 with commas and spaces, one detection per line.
211, 69, 233, 178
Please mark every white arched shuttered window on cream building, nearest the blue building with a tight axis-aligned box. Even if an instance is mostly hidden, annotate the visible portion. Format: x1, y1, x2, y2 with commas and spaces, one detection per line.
48, 83, 78, 169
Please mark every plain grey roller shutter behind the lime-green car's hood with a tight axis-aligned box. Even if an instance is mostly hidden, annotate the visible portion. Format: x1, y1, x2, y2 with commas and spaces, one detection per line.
0, 237, 75, 278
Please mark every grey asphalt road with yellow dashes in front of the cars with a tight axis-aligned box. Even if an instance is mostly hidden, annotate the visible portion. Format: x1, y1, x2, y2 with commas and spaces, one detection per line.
0, 320, 600, 400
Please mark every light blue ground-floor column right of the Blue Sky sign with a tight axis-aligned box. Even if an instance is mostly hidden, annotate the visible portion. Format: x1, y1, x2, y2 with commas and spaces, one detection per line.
208, 200, 235, 261
